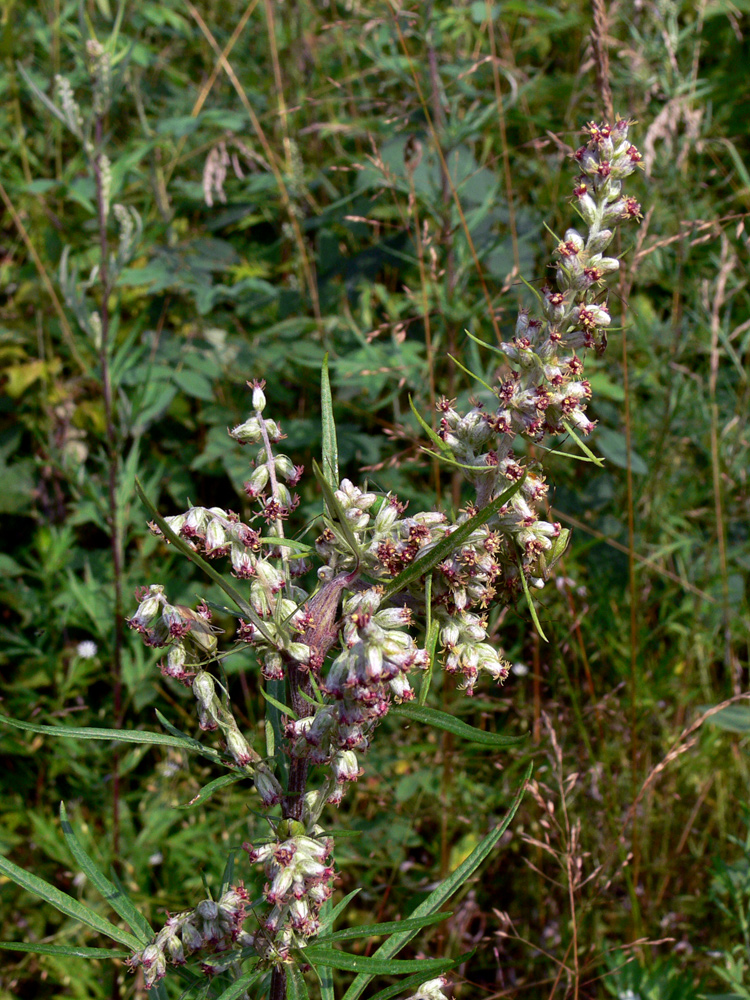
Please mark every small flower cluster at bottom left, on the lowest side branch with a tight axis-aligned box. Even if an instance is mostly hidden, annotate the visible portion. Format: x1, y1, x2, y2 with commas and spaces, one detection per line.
128, 882, 252, 989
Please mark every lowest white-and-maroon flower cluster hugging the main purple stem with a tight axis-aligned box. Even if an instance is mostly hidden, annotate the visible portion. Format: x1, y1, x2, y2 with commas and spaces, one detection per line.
242, 820, 334, 964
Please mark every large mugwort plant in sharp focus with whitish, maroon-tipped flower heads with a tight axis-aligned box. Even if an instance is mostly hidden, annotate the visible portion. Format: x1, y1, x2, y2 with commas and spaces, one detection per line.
3, 95, 641, 1000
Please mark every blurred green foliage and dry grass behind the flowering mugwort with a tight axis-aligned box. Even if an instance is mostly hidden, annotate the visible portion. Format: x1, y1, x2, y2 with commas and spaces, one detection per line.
0, 0, 750, 1000
